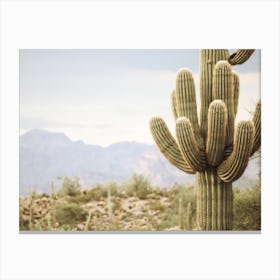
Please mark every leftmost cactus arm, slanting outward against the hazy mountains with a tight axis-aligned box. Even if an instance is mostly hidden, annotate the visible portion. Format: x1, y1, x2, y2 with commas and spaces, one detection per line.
150, 117, 195, 173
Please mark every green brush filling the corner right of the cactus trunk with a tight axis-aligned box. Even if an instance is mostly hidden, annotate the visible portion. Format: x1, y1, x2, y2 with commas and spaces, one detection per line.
233, 186, 261, 230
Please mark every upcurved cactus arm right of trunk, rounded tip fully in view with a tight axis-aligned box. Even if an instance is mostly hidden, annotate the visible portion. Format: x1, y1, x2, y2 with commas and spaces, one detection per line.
217, 121, 255, 182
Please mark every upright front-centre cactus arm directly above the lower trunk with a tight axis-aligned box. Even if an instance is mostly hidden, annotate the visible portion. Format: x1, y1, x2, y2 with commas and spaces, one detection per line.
206, 100, 227, 166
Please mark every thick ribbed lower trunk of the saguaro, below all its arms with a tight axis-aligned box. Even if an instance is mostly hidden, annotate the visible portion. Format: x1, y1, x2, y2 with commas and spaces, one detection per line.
196, 168, 233, 230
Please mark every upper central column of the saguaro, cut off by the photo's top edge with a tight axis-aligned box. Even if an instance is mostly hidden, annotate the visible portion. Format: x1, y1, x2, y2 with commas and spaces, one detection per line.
199, 49, 229, 139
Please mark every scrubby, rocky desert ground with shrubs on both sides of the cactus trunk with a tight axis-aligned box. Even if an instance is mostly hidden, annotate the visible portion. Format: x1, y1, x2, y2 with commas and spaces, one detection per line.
19, 174, 261, 231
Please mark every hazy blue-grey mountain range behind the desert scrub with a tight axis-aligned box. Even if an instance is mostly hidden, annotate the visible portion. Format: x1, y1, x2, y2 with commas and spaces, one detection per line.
20, 129, 258, 194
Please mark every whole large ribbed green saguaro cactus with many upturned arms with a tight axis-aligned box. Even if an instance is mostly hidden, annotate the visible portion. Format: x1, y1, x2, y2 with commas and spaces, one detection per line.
150, 49, 261, 230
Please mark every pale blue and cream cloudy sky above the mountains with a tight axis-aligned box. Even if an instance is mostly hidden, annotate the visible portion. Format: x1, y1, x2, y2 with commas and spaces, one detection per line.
20, 50, 261, 146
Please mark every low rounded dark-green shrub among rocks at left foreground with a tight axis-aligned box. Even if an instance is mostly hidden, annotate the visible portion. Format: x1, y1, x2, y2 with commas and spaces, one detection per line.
55, 203, 87, 226
